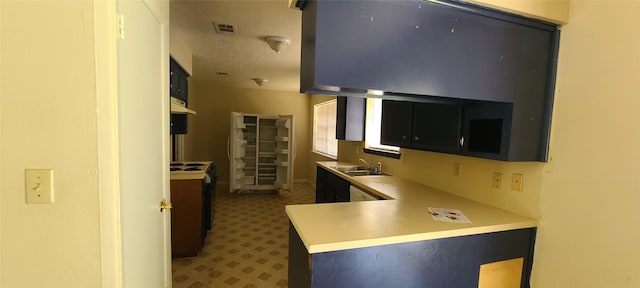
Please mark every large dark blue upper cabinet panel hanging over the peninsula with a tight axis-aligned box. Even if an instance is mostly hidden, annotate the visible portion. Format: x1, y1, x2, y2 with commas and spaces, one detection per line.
301, 0, 556, 102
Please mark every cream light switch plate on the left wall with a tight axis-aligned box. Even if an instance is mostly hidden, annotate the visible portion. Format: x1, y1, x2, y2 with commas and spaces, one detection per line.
24, 169, 54, 203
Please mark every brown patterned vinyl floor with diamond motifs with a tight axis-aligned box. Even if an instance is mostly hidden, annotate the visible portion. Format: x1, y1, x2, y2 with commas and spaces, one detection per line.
172, 183, 315, 288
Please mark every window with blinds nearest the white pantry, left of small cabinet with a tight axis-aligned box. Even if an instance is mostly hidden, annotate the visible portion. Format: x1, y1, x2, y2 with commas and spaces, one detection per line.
313, 99, 338, 158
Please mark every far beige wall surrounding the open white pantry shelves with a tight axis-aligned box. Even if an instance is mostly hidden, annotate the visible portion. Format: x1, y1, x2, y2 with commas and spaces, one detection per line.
185, 80, 311, 182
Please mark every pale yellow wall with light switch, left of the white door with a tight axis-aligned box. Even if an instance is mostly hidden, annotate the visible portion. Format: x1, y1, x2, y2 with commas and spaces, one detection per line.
0, 0, 101, 288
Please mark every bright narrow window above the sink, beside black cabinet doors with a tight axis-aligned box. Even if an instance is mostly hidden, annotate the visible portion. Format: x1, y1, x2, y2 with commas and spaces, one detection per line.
364, 98, 400, 158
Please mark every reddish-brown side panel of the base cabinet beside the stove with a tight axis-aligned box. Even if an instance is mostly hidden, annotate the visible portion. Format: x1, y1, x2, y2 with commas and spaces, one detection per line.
171, 179, 204, 258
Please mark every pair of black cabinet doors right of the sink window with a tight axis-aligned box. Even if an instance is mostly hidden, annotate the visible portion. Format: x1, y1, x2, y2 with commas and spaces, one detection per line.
380, 100, 462, 153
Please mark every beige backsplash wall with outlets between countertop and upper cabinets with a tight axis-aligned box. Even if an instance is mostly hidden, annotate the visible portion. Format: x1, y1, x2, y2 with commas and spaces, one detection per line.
338, 141, 544, 218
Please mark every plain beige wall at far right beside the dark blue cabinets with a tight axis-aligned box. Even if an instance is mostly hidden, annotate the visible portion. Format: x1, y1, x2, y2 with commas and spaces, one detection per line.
533, 0, 640, 288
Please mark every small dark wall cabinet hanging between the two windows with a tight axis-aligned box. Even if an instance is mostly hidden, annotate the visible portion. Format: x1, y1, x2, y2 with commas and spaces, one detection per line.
336, 96, 367, 141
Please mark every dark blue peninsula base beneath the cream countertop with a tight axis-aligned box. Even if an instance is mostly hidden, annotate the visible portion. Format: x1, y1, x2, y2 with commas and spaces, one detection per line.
289, 224, 536, 288
